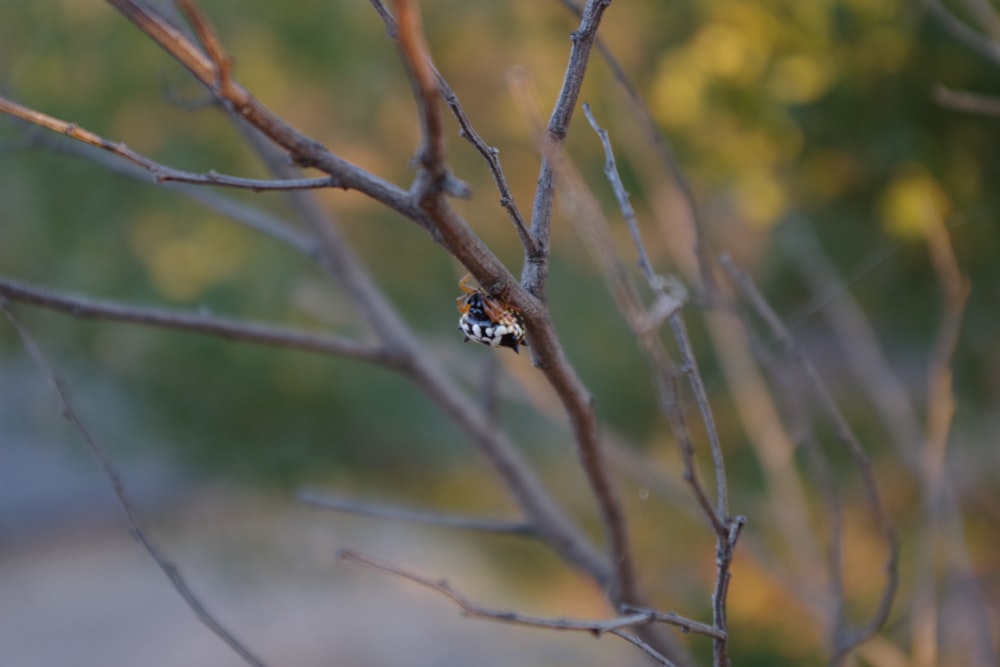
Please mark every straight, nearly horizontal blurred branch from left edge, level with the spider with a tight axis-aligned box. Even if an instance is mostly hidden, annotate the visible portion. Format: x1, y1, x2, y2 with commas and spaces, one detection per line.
0, 277, 400, 368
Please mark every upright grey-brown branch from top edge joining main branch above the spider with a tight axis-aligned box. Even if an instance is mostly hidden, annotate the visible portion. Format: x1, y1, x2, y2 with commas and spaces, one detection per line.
521, 0, 611, 298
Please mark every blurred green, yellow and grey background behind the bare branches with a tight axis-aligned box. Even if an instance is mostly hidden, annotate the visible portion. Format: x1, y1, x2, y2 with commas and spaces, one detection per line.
0, 0, 1000, 667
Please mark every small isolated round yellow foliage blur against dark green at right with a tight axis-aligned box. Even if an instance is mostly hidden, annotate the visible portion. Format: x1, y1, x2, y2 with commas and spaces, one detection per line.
879, 163, 951, 238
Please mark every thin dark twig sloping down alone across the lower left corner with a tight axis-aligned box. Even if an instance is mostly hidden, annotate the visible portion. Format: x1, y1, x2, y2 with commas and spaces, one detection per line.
0, 296, 264, 667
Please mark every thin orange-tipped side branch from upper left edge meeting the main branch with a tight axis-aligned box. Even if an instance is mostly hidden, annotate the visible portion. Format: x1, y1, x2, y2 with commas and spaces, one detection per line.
0, 96, 336, 192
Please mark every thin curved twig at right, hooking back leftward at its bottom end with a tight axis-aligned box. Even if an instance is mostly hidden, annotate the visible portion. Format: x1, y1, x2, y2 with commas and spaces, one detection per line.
721, 255, 899, 662
